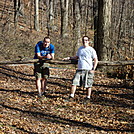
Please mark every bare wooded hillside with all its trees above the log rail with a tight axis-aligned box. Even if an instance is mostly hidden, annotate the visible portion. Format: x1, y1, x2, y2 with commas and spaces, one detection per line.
0, 0, 134, 61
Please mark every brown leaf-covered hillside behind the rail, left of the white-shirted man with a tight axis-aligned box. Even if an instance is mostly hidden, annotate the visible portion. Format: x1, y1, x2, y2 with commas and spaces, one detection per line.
0, 0, 94, 60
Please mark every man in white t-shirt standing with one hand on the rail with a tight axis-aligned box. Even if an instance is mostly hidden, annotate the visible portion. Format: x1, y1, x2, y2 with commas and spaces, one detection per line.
64, 36, 98, 99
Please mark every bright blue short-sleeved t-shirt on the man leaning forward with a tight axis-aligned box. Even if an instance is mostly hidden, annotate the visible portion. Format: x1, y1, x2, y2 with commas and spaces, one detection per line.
34, 41, 55, 59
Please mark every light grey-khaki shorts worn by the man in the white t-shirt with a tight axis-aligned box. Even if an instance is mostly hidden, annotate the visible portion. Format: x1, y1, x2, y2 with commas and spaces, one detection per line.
72, 70, 94, 88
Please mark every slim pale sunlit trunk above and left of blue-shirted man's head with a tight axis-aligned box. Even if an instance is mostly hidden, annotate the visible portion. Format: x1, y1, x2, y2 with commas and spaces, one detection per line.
34, 0, 39, 31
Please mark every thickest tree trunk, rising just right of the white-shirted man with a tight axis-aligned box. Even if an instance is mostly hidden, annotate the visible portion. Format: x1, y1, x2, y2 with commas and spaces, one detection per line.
97, 0, 112, 61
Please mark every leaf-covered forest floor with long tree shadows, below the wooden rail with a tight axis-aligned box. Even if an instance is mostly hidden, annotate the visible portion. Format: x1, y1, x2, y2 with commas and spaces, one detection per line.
0, 65, 134, 134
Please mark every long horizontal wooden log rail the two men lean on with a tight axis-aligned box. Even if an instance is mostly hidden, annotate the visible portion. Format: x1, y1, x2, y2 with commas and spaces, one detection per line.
0, 59, 134, 66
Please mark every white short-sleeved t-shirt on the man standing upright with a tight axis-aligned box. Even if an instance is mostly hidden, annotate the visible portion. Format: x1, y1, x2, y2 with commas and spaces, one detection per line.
76, 46, 97, 70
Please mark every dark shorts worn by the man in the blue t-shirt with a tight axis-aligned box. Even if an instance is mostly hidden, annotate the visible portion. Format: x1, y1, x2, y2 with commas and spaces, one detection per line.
34, 62, 50, 79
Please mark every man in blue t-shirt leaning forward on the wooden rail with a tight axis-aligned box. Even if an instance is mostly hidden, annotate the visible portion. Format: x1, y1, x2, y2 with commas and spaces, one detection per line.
34, 37, 55, 96
